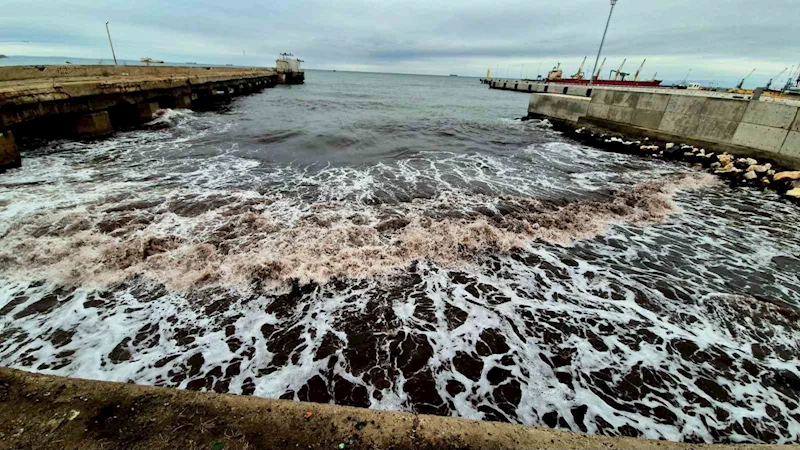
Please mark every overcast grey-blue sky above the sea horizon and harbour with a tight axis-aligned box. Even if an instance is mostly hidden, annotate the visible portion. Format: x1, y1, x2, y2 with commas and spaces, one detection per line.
0, 0, 800, 87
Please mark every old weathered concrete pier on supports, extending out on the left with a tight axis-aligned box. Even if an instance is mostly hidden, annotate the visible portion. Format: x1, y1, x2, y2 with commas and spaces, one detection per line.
0, 65, 279, 171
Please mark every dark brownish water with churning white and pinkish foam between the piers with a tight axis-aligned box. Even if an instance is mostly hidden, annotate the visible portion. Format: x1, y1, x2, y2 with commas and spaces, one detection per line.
0, 72, 800, 442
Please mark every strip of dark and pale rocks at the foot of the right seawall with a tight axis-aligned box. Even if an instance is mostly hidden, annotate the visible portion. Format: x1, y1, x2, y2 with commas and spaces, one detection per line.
522, 115, 800, 200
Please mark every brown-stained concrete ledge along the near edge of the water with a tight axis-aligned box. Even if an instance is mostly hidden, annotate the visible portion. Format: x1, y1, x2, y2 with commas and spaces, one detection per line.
0, 368, 800, 450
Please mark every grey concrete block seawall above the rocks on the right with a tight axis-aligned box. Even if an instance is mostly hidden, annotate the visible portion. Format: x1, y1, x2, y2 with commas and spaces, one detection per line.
516, 85, 800, 167
